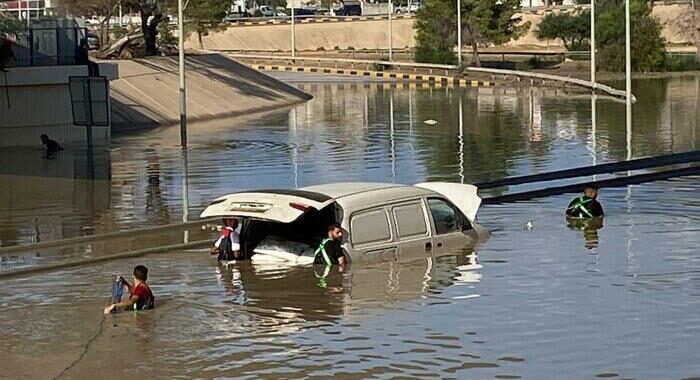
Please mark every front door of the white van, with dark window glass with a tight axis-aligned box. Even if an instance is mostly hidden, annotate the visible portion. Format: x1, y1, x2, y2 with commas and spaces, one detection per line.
426, 197, 476, 255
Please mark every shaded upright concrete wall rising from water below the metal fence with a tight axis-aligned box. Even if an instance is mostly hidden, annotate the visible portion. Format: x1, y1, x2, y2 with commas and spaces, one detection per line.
0, 65, 117, 147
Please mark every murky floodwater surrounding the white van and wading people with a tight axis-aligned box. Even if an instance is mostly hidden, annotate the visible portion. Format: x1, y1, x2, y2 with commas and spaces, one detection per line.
0, 77, 700, 380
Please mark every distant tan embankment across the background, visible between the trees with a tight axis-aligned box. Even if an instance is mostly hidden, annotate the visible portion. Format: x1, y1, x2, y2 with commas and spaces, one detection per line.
189, 4, 691, 53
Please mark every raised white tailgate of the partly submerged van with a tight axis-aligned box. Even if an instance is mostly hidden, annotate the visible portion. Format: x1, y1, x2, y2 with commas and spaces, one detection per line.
200, 189, 335, 223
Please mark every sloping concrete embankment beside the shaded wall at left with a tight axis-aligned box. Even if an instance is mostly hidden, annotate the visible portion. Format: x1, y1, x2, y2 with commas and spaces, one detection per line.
111, 54, 311, 131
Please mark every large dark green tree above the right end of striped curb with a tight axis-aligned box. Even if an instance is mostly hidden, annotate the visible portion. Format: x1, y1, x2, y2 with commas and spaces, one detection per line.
414, 0, 530, 66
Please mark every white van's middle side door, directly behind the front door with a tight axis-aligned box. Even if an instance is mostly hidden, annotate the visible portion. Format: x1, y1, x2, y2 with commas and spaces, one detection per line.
390, 198, 433, 260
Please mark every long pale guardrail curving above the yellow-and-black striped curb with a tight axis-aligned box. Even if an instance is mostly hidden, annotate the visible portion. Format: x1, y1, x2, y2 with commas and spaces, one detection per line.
223, 53, 637, 102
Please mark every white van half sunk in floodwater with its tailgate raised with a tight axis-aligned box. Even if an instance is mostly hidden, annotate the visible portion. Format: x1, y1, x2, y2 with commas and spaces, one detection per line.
200, 182, 489, 264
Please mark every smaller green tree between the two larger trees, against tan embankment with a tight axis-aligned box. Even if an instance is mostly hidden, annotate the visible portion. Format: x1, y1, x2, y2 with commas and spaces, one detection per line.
535, 11, 591, 51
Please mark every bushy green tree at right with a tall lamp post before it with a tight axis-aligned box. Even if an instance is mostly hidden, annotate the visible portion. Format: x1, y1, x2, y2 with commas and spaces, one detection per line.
596, 0, 666, 72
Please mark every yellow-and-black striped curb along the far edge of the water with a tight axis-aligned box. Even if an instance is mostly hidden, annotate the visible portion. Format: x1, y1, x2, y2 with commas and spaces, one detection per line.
249, 64, 497, 87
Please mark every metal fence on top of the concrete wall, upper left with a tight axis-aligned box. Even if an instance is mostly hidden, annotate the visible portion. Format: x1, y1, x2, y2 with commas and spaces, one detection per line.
6, 26, 87, 67
